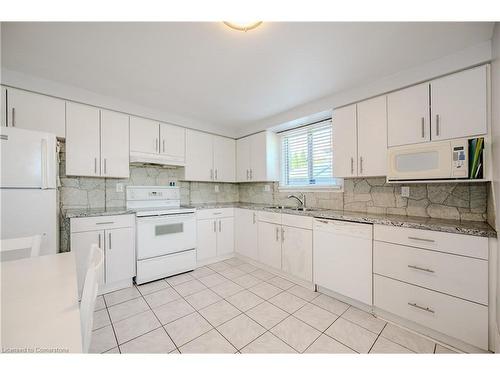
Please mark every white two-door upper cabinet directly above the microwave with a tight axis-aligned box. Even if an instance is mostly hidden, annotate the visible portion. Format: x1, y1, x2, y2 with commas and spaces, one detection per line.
387, 65, 488, 147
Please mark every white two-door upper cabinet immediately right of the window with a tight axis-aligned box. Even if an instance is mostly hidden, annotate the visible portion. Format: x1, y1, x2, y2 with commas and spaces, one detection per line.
332, 96, 387, 177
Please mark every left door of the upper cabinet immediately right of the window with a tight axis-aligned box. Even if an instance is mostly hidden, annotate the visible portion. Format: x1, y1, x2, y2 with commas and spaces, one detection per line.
332, 104, 357, 177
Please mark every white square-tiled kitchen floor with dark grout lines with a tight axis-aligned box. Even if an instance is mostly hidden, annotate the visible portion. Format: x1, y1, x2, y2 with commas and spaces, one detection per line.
91, 258, 460, 353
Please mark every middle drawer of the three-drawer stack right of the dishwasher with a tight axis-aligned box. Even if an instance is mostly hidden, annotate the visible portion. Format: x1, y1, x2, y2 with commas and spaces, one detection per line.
373, 241, 488, 305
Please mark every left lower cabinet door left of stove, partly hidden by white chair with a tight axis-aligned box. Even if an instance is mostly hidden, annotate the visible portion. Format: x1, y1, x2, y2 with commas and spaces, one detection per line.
71, 230, 104, 297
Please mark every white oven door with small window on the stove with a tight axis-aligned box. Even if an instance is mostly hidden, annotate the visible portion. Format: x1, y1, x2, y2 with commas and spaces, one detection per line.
137, 213, 196, 260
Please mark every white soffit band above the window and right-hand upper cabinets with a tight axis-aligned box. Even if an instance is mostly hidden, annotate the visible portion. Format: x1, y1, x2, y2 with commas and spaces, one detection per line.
242, 41, 491, 137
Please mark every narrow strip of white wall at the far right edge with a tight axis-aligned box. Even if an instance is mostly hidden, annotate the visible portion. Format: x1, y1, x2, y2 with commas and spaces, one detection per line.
491, 22, 500, 342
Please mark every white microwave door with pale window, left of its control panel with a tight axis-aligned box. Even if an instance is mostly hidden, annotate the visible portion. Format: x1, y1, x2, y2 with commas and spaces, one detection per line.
387, 142, 452, 181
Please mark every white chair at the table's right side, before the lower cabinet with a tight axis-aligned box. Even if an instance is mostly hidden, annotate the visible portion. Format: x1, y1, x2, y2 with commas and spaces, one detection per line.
80, 244, 104, 353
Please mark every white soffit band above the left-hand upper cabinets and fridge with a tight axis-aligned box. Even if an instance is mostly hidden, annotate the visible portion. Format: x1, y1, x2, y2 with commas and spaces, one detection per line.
0, 67, 235, 137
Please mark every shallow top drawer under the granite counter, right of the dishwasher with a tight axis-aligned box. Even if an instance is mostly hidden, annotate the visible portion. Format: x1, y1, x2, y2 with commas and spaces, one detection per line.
374, 225, 488, 259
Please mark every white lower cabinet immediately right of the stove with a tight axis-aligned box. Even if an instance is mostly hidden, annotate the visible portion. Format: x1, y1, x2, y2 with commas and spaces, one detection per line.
196, 208, 234, 262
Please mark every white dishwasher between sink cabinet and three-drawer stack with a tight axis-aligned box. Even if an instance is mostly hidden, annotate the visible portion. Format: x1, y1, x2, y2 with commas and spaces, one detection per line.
313, 219, 373, 305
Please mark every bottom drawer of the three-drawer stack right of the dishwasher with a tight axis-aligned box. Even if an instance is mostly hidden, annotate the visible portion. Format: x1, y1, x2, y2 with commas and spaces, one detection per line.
373, 275, 488, 350
